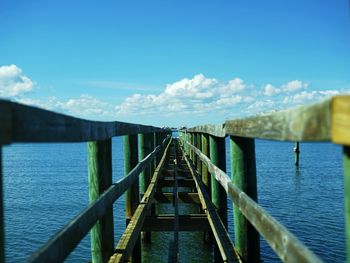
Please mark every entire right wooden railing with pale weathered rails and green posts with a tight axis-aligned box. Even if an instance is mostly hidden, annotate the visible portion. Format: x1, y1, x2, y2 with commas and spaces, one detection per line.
180, 96, 350, 262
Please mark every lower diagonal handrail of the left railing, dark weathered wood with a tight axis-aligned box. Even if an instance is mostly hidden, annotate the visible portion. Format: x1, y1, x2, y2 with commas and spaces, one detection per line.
27, 137, 170, 263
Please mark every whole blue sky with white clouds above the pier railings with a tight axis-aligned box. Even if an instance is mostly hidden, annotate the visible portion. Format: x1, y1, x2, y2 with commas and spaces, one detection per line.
0, 0, 350, 126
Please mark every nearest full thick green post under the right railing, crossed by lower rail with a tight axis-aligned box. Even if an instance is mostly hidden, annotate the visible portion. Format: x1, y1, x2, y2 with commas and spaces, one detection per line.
230, 136, 260, 262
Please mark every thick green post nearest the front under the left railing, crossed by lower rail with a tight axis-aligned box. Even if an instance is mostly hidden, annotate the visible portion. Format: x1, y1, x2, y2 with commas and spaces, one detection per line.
88, 139, 114, 263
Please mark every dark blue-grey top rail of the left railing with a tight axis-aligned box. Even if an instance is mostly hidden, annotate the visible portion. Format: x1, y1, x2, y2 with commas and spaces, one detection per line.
0, 100, 162, 144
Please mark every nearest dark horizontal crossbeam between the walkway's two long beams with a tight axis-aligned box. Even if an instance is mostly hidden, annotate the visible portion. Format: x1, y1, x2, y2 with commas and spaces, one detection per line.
142, 214, 210, 232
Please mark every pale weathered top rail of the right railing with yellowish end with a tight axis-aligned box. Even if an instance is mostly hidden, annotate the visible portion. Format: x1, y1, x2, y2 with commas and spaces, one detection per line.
186, 96, 350, 145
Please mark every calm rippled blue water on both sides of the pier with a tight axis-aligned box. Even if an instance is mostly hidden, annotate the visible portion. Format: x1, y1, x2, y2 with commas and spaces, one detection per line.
3, 138, 345, 262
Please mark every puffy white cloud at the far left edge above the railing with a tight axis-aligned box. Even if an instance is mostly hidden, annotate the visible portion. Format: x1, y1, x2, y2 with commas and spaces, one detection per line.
0, 65, 34, 98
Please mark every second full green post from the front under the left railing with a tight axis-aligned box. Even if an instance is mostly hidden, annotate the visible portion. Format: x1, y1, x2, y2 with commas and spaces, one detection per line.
124, 134, 141, 262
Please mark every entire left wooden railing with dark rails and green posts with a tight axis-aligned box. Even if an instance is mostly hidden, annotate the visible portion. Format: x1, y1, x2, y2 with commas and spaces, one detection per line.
0, 100, 171, 262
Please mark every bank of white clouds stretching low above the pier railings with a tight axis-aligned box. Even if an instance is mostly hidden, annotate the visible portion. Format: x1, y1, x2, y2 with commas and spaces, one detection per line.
0, 65, 341, 125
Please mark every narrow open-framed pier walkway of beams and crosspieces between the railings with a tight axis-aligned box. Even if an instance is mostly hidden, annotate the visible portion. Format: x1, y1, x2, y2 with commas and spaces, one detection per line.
109, 139, 238, 262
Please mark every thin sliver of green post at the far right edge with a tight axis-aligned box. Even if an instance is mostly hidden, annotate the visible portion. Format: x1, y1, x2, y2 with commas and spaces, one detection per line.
343, 146, 350, 262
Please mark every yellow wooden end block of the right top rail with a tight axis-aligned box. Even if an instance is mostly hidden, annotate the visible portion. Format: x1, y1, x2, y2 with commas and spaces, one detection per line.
332, 96, 350, 145
